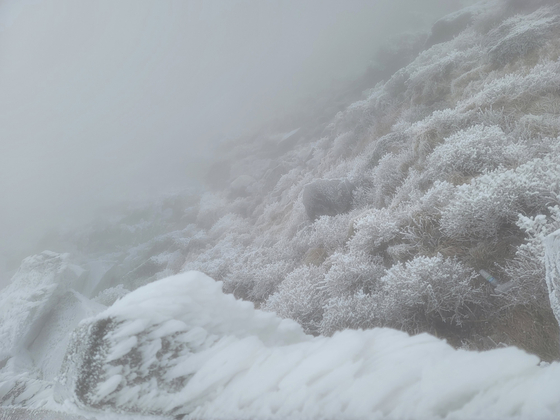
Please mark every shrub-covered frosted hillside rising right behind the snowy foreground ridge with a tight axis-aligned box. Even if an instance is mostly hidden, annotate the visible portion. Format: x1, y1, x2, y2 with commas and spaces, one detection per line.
187, 2, 560, 360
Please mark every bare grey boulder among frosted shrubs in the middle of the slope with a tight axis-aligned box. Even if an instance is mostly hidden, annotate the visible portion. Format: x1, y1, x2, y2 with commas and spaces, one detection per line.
303, 179, 354, 220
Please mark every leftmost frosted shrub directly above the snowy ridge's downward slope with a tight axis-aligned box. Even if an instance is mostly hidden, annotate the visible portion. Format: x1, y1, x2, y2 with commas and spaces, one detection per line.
262, 265, 326, 334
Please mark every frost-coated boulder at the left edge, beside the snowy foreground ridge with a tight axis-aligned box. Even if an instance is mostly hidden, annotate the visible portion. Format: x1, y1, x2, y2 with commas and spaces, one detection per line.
0, 251, 105, 410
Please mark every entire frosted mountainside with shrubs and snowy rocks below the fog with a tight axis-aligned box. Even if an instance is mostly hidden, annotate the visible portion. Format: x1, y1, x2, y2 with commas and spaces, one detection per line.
0, 0, 560, 419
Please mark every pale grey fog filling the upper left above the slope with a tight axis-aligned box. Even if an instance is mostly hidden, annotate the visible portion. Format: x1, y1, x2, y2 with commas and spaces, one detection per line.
0, 0, 472, 285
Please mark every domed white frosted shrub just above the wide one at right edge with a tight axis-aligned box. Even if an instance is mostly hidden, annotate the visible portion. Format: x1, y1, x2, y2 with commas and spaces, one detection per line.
426, 125, 527, 180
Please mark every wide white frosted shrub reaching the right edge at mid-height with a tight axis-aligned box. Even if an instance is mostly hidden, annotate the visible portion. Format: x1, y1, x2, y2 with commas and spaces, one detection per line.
441, 156, 560, 241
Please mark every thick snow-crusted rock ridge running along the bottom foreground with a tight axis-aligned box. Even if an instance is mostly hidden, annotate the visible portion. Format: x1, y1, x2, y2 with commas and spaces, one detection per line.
0, 271, 560, 419
